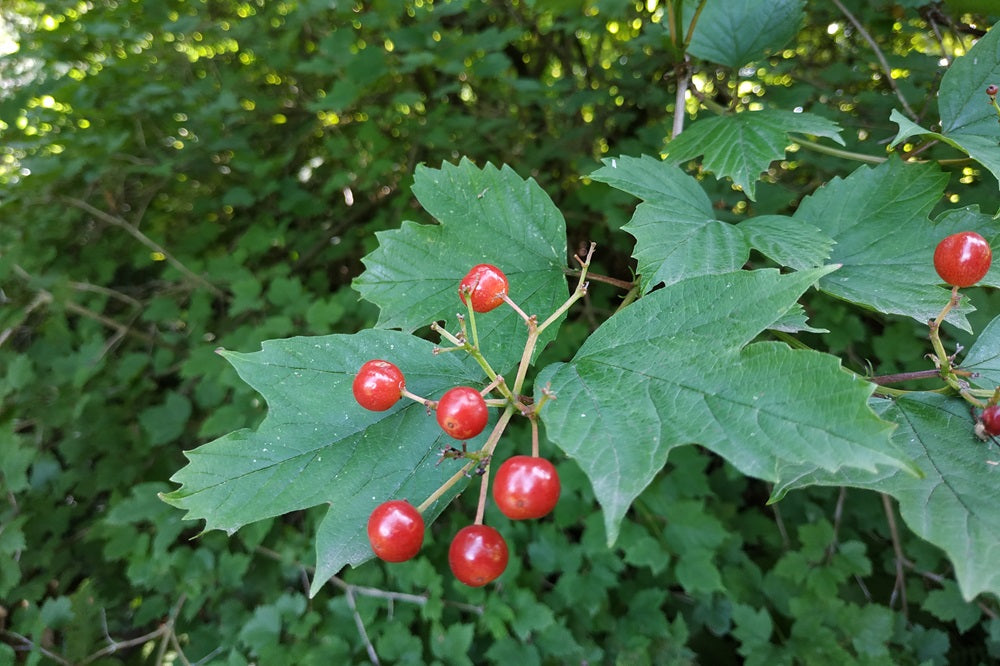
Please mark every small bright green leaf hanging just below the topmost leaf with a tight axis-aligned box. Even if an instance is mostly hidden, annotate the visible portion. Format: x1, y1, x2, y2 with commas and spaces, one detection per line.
667, 109, 844, 200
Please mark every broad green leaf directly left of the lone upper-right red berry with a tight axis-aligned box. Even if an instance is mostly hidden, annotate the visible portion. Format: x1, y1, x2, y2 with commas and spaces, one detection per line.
794, 159, 974, 330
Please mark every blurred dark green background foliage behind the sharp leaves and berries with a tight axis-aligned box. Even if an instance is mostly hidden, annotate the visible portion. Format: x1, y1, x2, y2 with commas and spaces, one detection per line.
0, 0, 1000, 666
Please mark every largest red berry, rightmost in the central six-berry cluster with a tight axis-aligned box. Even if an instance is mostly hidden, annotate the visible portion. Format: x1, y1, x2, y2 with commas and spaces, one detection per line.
493, 456, 561, 520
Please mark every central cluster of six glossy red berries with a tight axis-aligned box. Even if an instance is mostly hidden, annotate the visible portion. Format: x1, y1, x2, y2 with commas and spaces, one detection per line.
353, 264, 560, 587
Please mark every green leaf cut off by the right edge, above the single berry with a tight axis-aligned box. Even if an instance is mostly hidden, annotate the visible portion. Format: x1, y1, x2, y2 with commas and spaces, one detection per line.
889, 21, 1000, 187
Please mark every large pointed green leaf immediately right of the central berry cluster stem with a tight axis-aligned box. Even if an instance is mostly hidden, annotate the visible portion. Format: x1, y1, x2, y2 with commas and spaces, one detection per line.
536, 267, 913, 543
